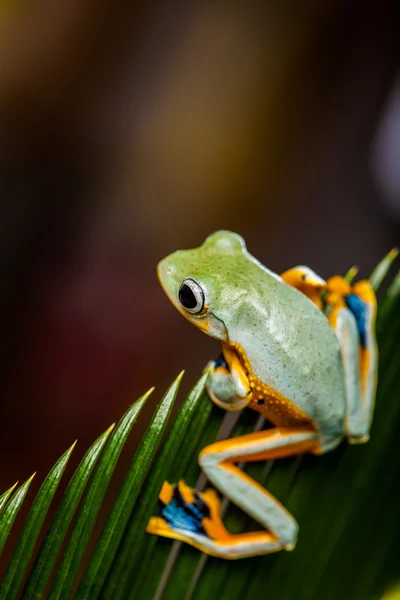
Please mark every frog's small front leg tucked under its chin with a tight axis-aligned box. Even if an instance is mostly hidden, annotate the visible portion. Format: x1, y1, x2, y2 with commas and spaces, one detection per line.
207, 344, 251, 411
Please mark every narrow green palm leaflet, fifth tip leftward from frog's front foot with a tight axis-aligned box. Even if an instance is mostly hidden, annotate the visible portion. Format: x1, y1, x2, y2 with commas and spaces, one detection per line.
0, 442, 76, 600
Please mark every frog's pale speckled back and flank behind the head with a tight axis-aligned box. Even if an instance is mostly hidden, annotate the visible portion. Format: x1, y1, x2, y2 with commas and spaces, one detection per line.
225, 255, 345, 436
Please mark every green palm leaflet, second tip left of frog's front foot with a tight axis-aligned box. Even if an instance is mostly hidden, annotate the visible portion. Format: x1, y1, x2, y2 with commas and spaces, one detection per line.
76, 373, 183, 598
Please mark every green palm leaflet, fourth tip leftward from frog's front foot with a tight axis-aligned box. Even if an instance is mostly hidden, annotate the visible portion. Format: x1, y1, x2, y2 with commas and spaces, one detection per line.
22, 425, 114, 600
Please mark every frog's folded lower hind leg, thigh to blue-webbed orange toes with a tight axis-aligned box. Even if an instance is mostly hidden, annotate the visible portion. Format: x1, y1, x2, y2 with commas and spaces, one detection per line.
147, 427, 321, 559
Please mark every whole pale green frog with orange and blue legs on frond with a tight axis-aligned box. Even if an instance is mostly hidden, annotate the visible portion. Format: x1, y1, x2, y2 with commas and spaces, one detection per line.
147, 230, 390, 559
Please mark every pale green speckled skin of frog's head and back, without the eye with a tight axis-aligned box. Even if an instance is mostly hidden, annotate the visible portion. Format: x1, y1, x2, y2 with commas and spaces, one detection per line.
158, 231, 346, 450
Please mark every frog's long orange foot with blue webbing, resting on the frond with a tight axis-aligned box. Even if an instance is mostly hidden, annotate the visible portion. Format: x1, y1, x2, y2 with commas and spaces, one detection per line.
146, 480, 282, 559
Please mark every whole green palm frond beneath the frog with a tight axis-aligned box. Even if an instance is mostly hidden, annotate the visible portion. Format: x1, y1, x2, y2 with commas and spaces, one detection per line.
0, 265, 400, 600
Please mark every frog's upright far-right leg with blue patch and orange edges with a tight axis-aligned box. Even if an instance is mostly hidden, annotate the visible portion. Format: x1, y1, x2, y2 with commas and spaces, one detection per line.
328, 281, 377, 443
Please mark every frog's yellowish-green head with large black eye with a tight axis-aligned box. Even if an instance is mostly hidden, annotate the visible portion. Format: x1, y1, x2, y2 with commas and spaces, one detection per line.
157, 231, 249, 342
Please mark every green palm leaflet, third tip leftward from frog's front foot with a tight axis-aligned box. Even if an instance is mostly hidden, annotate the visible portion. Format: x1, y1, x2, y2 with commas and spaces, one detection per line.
49, 389, 153, 600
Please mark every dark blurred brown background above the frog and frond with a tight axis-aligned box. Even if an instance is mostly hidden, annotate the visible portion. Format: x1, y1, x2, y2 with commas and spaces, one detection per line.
0, 0, 400, 568
